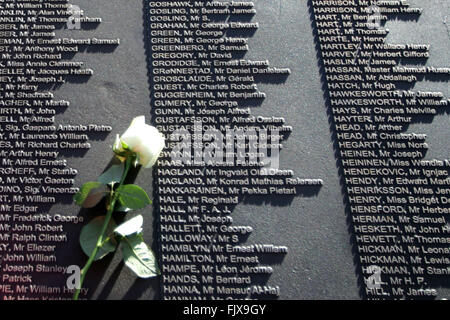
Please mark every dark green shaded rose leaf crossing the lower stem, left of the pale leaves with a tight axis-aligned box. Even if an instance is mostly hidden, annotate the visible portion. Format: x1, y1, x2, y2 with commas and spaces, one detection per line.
80, 216, 117, 260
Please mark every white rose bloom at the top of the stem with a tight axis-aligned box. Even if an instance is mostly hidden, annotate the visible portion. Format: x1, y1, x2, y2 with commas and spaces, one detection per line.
113, 116, 165, 168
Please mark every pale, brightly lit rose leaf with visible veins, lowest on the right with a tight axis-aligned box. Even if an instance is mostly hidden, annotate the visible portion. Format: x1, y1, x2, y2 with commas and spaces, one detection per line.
121, 234, 161, 278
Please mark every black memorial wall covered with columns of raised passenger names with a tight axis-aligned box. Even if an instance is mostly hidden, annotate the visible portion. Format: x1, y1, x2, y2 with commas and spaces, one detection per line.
0, 0, 450, 300
